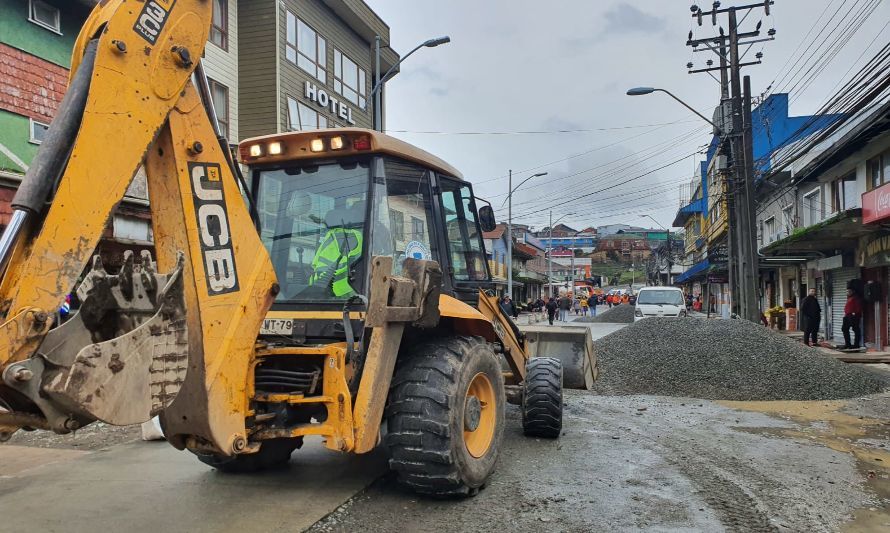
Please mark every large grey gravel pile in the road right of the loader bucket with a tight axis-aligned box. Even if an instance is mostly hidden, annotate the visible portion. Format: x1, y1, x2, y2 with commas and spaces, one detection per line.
594, 316, 890, 400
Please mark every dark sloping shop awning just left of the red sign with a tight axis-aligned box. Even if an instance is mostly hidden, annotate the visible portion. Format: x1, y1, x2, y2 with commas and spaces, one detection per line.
760, 209, 877, 257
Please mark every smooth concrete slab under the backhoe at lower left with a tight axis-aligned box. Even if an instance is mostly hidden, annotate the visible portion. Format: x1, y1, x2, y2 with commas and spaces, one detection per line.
0, 441, 386, 533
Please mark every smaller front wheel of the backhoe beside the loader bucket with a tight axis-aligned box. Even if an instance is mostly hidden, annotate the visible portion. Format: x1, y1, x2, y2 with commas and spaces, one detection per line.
522, 357, 562, 439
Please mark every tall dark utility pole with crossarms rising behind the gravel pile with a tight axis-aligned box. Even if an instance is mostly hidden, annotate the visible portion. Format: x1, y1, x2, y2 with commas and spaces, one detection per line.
687, 0, 775, 322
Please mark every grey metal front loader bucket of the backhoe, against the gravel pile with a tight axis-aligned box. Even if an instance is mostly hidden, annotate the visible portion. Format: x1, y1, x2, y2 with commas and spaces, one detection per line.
522, 326, 599, 389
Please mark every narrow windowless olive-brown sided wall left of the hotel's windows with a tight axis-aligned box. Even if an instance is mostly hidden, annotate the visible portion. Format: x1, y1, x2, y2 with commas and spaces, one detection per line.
237, 0, 278, 139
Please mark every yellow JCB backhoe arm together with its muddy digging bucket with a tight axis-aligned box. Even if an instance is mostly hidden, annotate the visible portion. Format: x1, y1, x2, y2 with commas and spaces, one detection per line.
0, 0, 278, 455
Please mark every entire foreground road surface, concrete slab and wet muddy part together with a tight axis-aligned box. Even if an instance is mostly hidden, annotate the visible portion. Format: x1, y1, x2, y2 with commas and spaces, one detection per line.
0, 314, 890, 533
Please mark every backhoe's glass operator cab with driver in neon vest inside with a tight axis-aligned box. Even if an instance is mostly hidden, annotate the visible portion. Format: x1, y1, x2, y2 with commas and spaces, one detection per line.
240, 128, 494, 340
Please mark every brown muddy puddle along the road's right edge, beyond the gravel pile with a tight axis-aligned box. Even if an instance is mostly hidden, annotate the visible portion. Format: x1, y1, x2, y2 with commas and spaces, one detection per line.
717, 400, 890, 533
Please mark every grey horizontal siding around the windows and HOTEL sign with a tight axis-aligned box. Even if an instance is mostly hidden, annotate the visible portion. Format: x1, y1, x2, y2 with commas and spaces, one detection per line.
278, 0, 373, 131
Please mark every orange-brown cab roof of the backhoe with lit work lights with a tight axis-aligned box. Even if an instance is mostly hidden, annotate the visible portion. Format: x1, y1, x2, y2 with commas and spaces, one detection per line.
238, 128, 464, 180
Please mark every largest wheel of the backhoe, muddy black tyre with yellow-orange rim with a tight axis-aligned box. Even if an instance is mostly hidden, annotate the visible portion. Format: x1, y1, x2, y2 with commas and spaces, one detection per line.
385, 337, 506, 496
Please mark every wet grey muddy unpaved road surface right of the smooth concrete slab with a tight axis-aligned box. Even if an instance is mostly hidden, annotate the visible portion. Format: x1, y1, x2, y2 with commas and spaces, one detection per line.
310, 391, 890, 533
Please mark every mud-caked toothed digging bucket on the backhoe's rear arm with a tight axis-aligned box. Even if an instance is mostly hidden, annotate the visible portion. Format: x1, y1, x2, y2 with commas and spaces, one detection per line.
4, 251, 188, 431
